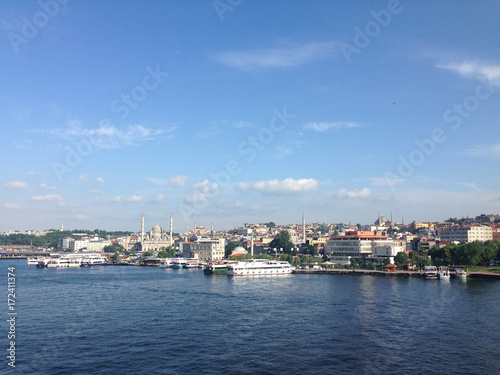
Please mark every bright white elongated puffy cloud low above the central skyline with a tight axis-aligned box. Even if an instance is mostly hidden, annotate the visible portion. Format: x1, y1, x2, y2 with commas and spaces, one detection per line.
236, 178, 318, 194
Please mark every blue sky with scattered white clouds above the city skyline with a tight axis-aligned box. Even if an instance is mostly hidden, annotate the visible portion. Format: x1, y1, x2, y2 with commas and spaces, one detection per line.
0, 0, 500, 232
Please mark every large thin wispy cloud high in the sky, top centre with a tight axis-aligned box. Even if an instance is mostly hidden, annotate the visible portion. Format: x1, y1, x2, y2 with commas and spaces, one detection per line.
215, 42, 338, 71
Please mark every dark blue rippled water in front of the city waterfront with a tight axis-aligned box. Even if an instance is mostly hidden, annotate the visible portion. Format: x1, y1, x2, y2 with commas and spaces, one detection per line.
0, 260, 500, 375
